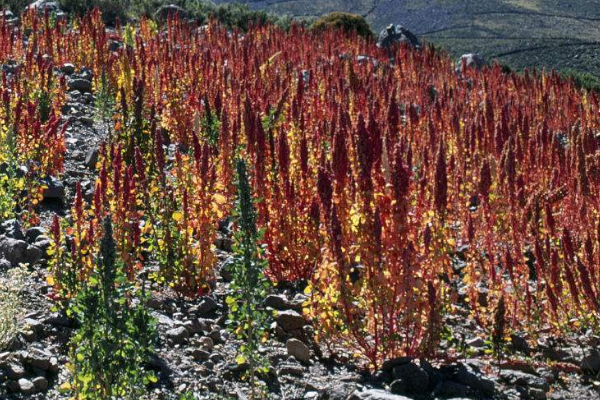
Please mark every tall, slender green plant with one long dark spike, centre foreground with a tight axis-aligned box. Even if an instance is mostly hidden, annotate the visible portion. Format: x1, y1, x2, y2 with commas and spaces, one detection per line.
227, 160, 270, 398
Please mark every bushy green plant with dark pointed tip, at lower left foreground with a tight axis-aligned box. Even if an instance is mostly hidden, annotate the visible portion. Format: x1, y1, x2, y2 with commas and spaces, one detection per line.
68, 217, 157, 399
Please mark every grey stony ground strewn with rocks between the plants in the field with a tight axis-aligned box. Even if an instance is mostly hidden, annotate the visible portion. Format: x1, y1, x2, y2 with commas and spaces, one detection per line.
0, 16, 600, 400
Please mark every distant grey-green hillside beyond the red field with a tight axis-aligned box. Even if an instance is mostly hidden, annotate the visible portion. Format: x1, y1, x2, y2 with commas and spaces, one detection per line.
215, 0, 600, 76
